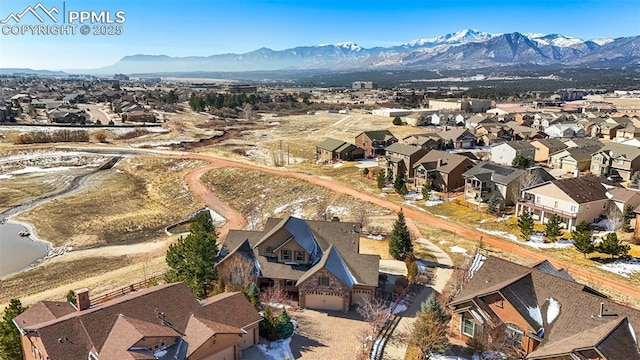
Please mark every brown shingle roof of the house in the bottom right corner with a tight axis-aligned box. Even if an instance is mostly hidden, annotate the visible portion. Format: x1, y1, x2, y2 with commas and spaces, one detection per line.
451, 256, 640, 359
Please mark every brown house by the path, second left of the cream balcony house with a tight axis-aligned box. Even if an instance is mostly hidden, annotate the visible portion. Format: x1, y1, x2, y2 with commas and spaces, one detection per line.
414, 150, 474, 192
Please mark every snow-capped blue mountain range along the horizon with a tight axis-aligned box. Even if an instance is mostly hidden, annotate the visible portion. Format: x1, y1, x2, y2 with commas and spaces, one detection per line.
71, 29, 640, 74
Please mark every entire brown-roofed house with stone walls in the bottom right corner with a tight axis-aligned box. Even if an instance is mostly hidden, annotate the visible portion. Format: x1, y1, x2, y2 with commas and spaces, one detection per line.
449, 254, 640, 360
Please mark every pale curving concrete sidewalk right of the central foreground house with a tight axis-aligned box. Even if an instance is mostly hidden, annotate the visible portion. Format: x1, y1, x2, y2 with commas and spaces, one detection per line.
383, 219, 453, 360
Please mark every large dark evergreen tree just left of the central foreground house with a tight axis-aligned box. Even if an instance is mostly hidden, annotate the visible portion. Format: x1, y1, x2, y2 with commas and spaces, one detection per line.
165, 214, 218, 299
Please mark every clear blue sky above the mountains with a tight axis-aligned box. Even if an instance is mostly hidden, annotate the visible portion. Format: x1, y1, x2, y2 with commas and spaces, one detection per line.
0, 0, 640, 70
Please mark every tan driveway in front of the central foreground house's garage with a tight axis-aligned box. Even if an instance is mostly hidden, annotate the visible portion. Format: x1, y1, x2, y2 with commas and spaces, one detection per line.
291, 309, 367, 360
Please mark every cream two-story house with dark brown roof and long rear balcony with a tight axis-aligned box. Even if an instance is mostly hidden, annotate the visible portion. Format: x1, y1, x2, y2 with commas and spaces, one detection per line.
516, 176, 619, 230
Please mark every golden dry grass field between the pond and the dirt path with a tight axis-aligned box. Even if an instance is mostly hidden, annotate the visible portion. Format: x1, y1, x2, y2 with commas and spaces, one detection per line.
17, 158, 205, 248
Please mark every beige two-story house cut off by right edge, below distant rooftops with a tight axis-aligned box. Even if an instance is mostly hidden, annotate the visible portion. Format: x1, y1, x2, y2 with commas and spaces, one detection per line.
591, 143, 640, 181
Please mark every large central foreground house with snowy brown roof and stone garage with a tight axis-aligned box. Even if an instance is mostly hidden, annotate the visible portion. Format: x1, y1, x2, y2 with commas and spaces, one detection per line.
216, 216, 380, 312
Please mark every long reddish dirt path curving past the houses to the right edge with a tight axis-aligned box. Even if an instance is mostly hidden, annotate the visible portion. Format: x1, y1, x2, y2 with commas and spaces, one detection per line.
184, 154, 640, 299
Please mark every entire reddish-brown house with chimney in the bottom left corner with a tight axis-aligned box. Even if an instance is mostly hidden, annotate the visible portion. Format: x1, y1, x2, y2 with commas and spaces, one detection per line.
13, 283, 261, 360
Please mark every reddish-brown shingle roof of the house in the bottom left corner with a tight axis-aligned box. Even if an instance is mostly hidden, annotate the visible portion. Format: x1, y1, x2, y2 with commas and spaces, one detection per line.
18, 283, 258, 360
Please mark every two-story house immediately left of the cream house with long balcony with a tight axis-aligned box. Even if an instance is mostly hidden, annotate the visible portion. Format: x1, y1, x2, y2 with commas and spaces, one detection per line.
462, 162, 554, 206
